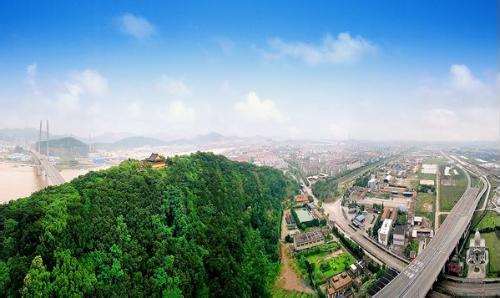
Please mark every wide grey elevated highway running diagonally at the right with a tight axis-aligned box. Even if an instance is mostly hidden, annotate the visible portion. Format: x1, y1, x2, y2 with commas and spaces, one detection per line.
374, 152, 488, 297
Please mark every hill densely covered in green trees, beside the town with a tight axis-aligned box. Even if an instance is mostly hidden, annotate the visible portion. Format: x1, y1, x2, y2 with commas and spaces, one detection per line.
0, 153, 296, 297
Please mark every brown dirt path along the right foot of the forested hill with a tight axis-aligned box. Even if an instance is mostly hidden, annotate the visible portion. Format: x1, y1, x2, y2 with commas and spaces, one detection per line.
275, 211, 314, 294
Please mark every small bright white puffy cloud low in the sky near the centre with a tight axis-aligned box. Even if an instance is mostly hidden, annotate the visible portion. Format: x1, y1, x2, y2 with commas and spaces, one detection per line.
236, 91, 285, 122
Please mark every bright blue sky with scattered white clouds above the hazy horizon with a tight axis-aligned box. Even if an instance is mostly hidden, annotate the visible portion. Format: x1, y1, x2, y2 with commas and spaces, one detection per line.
0, 1, 499, 140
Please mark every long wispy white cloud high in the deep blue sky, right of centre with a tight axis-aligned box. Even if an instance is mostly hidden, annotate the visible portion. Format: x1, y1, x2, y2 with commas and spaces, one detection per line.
266, 32, 377, 65
